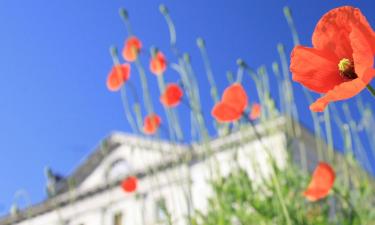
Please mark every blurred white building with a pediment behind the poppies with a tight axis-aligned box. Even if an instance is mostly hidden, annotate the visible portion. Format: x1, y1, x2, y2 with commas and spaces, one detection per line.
0, 118, 326, 225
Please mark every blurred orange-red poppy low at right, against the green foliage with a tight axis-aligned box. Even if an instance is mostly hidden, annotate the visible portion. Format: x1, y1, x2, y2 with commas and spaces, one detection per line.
303, 162, 336, 201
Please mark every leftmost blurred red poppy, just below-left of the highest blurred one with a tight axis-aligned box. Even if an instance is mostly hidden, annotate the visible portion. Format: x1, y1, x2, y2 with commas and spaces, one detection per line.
107, 63, 130, 91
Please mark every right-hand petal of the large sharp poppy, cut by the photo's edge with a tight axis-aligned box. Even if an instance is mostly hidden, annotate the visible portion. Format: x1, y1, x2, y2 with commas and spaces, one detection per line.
350, 27, 374, 84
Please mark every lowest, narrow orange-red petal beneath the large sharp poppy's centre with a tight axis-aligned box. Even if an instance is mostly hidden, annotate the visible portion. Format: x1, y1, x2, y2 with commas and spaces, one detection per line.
310, 68, 375, 112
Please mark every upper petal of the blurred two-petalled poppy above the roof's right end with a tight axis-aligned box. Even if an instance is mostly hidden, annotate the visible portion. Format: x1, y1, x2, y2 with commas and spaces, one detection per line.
222, 84, 248, 114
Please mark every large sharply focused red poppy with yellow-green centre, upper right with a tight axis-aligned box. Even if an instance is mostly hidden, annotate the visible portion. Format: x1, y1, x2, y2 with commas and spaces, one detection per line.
290, 6, 375, 112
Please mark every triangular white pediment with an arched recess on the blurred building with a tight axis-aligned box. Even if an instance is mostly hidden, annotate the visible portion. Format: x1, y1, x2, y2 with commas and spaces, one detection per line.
57, 132, 187, 194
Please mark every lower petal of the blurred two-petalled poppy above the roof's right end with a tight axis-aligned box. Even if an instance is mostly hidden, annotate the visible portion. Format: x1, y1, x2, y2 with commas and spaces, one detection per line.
211, 102, 242, 123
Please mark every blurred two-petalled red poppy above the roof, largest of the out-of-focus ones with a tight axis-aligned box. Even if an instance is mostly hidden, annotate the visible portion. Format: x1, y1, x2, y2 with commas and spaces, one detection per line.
211, 84, 248, 122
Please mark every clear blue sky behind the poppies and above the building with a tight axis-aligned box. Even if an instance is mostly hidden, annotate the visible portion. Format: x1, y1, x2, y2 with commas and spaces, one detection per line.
0, 0, 375, 214
